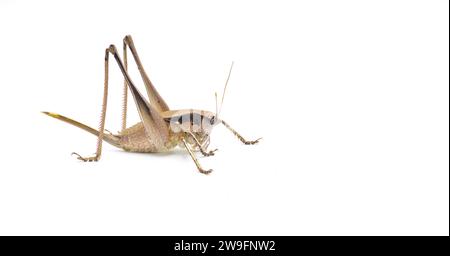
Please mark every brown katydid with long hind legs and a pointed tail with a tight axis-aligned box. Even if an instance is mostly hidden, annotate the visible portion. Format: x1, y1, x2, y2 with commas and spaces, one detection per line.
42, 35, 261, 174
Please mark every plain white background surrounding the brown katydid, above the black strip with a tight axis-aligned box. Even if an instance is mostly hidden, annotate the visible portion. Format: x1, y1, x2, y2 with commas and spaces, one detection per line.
0, 0, 449, 235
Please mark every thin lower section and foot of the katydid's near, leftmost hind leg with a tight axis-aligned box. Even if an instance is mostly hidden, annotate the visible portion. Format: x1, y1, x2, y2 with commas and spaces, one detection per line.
72, 49, 109, 162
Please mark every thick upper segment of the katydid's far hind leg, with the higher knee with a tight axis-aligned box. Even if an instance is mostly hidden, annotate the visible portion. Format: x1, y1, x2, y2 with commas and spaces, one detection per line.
123, 35, 169, 112
